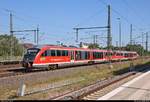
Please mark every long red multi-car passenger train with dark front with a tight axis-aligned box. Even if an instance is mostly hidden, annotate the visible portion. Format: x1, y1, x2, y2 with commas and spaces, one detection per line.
22, 45, 139, 69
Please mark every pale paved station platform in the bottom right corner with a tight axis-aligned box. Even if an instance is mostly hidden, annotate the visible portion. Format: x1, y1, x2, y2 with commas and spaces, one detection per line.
98, 70, 150, 100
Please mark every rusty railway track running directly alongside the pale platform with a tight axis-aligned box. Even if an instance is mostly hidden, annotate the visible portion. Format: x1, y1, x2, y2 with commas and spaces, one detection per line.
53, 66, 149, 100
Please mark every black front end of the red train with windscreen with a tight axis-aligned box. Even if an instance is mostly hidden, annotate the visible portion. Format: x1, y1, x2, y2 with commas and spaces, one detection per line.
22, 48, 40, 68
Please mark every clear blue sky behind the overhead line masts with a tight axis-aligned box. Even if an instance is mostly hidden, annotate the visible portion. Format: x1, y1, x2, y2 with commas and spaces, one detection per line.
0, 0, 150, 46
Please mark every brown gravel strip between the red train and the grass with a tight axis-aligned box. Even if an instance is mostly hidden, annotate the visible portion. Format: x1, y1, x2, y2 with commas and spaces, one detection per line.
0, 65, 107, 88
